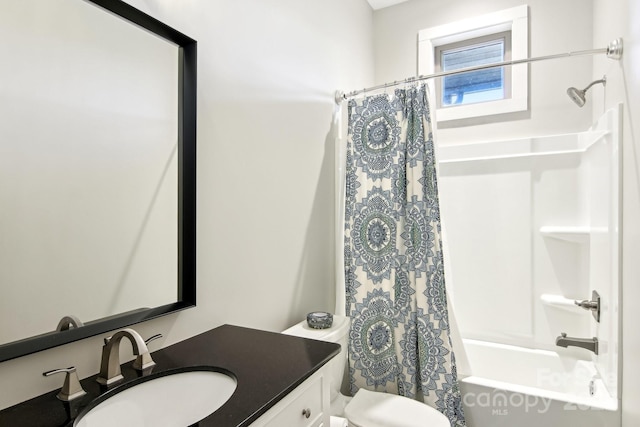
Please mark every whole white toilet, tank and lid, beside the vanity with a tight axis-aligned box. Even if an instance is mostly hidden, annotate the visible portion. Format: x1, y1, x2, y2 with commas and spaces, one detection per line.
282, 315, 451, 427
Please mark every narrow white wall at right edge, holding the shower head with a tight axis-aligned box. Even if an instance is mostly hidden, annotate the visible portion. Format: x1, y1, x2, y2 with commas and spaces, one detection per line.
593, 0, 640, 427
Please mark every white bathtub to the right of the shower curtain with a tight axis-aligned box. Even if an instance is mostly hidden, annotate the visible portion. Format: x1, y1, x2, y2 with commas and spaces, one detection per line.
459, 339, 620, 427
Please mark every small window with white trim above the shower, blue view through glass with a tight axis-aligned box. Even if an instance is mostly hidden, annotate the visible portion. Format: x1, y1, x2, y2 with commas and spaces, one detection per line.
418, 6, 528, 122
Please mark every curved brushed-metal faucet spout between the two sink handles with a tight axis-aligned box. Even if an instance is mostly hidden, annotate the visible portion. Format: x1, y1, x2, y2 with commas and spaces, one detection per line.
96, 328, 155, 385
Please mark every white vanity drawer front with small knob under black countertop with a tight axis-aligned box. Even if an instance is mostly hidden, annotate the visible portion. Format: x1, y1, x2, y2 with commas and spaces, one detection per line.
252, 373, 328, 427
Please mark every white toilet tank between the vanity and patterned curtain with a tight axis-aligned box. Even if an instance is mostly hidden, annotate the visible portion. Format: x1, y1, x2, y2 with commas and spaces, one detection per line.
282, 315, 351, 401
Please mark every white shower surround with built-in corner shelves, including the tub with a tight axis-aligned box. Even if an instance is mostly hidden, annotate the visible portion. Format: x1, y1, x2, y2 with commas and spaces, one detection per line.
438, 106, 621, 426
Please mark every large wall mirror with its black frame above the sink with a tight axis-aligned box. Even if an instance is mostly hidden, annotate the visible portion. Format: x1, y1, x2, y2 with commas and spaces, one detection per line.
0, 0, 197, 362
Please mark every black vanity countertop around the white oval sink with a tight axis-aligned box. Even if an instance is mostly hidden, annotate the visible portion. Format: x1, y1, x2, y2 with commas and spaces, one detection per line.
0, 325, 340, 427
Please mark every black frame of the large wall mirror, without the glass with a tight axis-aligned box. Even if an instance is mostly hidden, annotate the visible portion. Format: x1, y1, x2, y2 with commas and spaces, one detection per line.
0, 0, 197, 362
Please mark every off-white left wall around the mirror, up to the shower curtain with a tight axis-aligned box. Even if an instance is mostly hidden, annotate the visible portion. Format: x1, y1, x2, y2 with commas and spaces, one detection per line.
0, 0, 373, 408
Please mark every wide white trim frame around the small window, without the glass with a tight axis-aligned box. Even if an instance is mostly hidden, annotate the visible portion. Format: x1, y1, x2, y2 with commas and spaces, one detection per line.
418, 5, 529, 122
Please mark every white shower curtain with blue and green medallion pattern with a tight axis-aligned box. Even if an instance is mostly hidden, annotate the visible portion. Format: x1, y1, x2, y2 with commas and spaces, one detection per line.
344, 85, 465, 427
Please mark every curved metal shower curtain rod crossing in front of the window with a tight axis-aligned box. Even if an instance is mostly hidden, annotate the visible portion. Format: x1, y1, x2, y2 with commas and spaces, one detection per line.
335, 38, 622, 104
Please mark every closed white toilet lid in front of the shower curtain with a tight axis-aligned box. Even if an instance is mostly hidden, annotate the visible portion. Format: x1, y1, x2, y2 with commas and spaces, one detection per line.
344, 389, 451, 427
